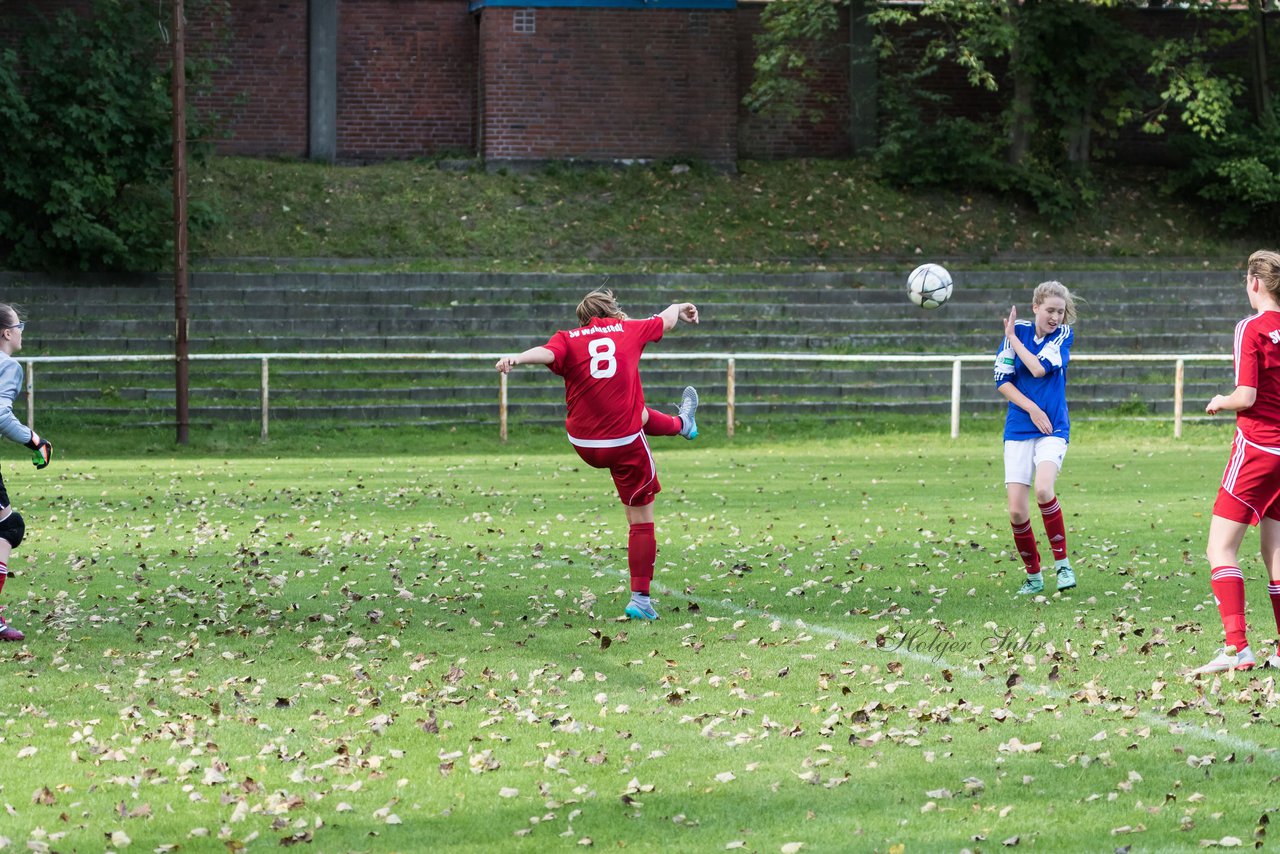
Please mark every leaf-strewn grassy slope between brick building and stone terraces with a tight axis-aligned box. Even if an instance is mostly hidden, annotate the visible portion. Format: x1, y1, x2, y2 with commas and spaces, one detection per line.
192, 157, 1265, 270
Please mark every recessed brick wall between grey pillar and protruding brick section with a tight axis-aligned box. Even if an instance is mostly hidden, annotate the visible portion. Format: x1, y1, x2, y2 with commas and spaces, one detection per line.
338, 0, 477, 159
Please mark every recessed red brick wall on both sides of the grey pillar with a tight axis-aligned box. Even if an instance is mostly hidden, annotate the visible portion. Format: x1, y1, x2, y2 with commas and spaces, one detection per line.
191, 0, 476, 160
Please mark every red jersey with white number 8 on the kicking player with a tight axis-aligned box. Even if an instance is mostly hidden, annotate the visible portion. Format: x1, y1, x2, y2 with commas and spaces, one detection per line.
547, 315, 666, 440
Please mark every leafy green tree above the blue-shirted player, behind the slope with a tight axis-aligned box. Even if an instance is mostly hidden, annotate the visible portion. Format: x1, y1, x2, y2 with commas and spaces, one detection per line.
872, 0, 1143, 219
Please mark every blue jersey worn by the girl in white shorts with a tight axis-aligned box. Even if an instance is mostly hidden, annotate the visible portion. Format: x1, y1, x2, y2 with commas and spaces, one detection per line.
996, 320, 1074, 442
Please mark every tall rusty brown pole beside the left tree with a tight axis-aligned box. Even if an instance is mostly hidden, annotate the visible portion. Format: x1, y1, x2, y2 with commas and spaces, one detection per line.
173, 0, 191, 444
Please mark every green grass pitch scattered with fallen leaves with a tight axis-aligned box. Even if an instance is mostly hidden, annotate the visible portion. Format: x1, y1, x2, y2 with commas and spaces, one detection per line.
0, 423, 1280, 851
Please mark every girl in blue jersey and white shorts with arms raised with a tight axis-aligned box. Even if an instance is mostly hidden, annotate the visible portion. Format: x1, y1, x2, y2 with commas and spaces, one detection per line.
996, 282, 1075, 595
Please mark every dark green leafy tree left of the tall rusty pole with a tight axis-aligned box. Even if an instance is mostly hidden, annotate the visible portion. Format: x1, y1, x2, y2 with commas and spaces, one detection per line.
0, 0, 217, 270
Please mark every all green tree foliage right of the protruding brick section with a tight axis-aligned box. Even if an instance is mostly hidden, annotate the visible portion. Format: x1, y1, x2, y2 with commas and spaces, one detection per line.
748, 0, 1275, 226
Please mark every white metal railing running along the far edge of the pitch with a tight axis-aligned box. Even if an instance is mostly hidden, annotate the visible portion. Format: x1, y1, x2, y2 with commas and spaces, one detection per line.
22, 352, 1231, 442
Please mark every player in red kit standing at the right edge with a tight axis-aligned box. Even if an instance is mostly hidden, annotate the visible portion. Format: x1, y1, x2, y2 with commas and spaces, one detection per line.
1194, 250, 1280, 673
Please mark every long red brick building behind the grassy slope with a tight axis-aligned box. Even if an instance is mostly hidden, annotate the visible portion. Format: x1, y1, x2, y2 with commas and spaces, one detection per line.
0, 0, 1259, 168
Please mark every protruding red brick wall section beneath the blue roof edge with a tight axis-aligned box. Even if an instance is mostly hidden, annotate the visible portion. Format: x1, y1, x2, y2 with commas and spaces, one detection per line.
480, 8, 737, 165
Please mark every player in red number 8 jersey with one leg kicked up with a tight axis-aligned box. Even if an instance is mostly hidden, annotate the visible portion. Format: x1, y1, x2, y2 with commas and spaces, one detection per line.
495, 291, 698, 620
